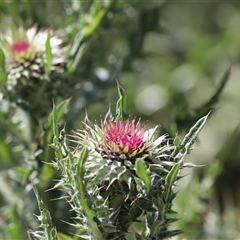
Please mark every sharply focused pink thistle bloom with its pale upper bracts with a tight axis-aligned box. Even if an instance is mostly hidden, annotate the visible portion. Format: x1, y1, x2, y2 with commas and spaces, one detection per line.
75, 117, 167, 164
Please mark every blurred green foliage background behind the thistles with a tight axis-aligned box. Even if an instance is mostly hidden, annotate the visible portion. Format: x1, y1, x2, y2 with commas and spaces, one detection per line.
0, 0, 240, 239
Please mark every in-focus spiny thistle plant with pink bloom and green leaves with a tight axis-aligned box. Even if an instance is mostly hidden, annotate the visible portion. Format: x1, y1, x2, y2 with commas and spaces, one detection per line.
32, 83, 207, 240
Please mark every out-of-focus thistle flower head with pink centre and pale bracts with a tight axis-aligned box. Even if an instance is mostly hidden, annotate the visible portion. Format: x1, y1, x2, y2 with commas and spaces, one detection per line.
0, 25, 66, 90
